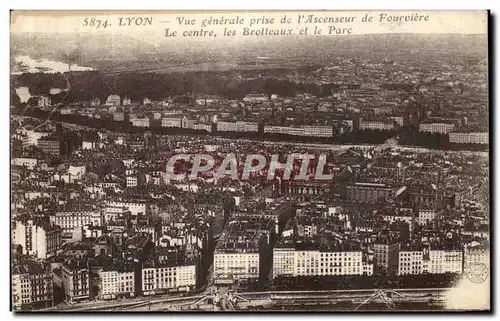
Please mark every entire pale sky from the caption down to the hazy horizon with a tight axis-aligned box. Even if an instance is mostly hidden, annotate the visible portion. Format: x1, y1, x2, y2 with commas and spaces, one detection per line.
10, 11, 488, 74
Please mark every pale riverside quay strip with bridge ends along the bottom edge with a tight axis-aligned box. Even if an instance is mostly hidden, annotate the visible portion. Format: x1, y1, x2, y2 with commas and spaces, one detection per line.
53, 288, 450, 312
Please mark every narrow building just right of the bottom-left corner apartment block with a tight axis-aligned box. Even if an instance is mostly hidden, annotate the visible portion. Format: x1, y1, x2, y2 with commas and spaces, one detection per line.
61, 259, 90, 304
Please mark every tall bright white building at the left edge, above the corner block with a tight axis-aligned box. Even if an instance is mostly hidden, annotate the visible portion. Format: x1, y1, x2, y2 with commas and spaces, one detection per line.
12, 220, 62, 259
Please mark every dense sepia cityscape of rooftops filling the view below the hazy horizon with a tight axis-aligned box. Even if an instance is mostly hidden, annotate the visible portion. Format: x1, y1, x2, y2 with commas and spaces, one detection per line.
11, 31, 490, 311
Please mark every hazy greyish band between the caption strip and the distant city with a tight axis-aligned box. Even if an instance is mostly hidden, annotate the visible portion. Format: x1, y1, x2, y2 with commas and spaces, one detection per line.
11, 32, 488, 60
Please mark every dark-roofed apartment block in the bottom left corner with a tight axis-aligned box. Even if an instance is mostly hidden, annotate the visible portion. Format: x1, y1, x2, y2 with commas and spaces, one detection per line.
11, 260, 54, 311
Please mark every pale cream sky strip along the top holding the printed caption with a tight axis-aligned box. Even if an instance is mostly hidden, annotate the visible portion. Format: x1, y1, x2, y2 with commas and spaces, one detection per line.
11, 10, 488, 40
